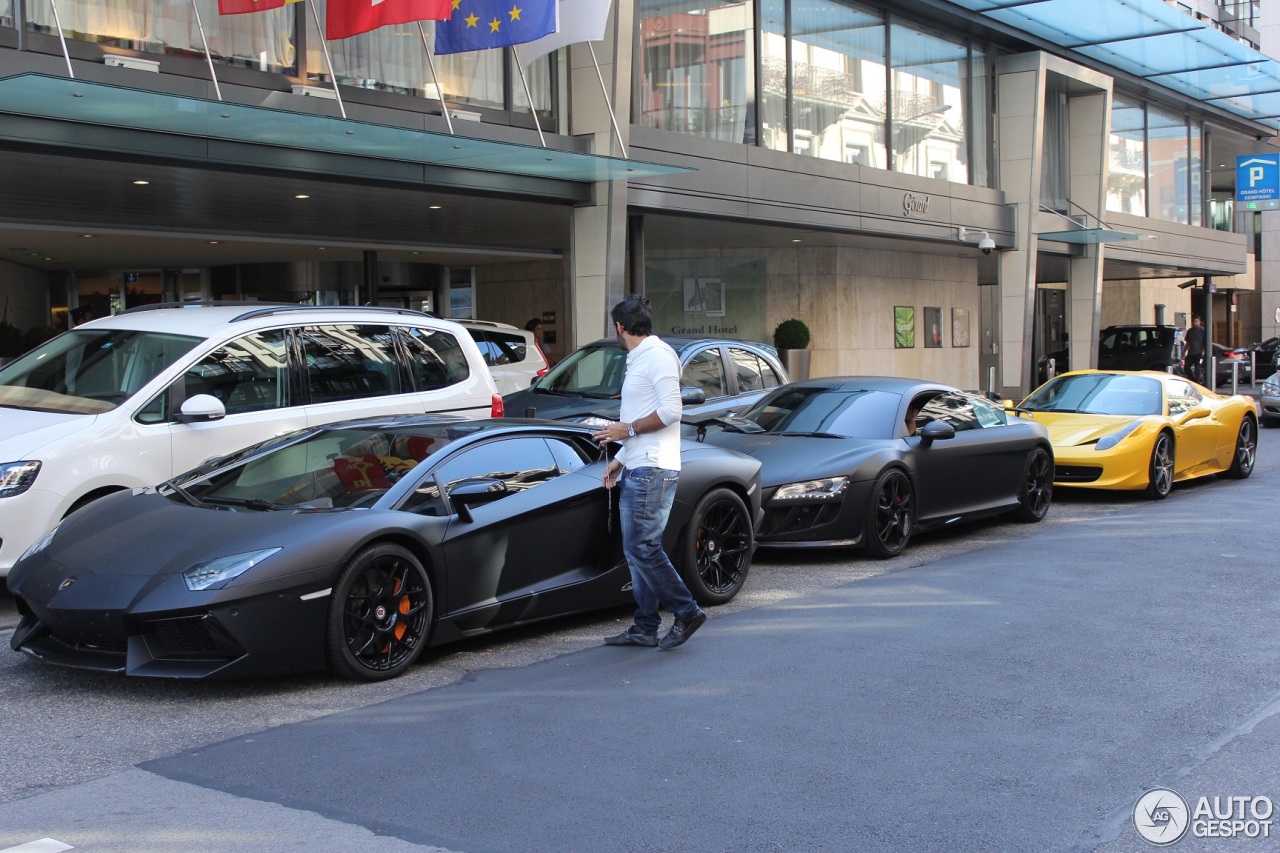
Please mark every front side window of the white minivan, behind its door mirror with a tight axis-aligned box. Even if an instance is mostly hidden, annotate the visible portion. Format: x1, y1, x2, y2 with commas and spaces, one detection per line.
179, 329, 291, 415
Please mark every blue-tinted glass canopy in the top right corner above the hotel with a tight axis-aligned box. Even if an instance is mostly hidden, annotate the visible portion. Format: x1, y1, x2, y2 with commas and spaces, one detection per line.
951, 0, 1280, 129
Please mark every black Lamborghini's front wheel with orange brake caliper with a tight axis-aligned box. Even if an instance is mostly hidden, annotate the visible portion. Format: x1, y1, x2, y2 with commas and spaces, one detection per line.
325, 543, 434, 681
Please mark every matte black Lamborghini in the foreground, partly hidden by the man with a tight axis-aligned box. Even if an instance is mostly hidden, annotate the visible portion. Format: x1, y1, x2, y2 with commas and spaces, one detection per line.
9, 415, 760, 680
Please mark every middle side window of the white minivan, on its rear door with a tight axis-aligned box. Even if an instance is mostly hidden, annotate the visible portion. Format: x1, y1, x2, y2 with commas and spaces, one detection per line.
298, 324, 403, 403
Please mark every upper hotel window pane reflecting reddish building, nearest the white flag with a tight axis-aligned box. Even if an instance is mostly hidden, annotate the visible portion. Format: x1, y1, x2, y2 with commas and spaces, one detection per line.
636, 0, 755, 145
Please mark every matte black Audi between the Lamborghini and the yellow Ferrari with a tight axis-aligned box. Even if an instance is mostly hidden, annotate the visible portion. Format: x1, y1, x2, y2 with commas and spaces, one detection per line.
701, 377, 1053, 557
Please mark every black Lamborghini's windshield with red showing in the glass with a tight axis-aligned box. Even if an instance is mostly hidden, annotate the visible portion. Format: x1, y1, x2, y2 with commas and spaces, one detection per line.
183, 420, 485, 508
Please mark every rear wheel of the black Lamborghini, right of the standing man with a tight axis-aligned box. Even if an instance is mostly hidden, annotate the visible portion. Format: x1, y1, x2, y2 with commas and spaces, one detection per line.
680, 488, 755, 606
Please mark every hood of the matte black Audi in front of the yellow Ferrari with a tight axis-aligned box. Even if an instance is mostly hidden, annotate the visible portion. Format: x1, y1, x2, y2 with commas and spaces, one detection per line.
707, 429, 886, 488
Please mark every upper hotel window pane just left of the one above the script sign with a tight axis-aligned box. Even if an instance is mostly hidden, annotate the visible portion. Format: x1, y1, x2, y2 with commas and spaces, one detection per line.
791, 0, 890, 169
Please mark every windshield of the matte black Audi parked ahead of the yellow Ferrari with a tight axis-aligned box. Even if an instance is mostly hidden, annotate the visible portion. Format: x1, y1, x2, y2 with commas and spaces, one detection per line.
742, 387, 902, 438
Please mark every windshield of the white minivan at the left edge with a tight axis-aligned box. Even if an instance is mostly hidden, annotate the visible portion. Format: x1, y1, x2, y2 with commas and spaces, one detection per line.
0, 329, 201, 415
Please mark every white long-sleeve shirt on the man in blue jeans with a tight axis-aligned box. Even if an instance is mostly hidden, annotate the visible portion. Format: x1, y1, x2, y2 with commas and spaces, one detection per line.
616, 334, 684, 471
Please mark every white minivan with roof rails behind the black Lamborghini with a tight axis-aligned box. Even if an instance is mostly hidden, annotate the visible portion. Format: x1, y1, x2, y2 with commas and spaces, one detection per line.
0, 304, 502, 578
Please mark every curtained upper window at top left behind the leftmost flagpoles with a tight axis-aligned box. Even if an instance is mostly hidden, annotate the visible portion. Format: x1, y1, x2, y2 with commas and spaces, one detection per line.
26, 0, 296, 72
